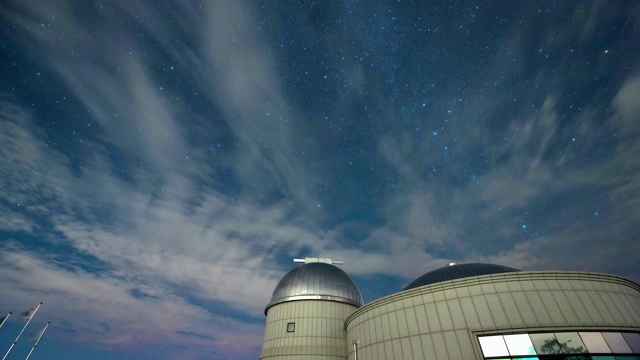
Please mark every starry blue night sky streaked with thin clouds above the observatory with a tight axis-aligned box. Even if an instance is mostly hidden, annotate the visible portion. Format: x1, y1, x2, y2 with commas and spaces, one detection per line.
0, 0, 640, 360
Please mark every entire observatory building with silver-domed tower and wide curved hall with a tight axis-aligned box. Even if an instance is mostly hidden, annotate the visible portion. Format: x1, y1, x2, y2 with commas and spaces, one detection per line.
260, 258, 640, 360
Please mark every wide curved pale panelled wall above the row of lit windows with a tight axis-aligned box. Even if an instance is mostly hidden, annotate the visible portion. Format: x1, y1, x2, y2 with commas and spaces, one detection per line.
346, 271, 640, 360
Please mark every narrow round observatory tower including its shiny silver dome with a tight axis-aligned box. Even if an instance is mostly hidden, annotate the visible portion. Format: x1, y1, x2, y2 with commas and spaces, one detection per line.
260, 258, 363, 360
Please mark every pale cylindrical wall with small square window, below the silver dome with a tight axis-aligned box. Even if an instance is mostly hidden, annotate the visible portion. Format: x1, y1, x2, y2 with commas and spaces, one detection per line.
260, 300, 357, 360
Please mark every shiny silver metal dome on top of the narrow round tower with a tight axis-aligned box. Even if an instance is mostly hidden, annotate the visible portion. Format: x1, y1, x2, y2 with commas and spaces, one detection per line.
264, 262, 364, 314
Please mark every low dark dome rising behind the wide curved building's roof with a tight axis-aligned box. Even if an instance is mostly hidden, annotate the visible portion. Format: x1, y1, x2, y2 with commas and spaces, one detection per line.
404, 263, 520, 290
